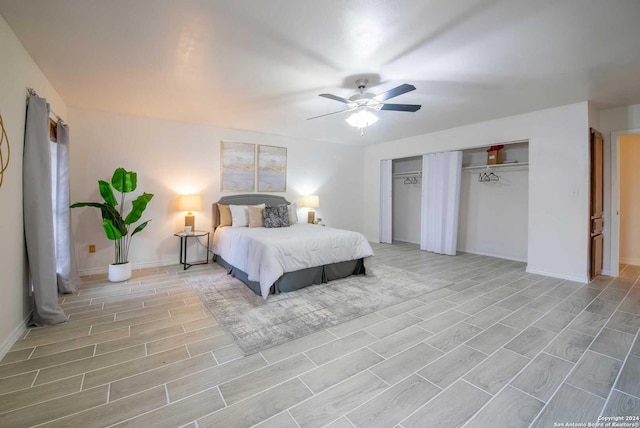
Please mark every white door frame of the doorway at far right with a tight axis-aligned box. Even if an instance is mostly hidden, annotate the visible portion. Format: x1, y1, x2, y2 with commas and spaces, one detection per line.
609, 128, 640, 276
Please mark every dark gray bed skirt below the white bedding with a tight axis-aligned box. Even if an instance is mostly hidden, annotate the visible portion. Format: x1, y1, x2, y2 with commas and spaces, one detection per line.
214, 256, 366, 296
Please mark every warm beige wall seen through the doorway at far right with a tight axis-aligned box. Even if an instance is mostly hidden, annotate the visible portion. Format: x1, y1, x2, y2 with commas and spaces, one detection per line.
620, 135, 640, 266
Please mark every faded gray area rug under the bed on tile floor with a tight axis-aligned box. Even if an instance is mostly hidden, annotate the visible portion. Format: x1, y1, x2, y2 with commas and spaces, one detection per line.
189, 265, 452, 355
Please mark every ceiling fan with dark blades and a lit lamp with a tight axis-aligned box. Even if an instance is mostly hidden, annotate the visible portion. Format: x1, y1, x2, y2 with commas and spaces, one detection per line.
307, 79, 422, 135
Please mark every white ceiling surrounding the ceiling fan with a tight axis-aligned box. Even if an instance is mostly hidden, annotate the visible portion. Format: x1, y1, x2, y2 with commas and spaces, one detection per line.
0, 0, 640, 145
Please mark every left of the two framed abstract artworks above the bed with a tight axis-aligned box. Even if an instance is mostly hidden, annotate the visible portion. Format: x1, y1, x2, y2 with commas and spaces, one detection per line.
220, 141, 256, 192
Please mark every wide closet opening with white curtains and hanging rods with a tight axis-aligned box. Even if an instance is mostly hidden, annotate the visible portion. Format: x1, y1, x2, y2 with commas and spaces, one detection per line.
380, 140, 529, 262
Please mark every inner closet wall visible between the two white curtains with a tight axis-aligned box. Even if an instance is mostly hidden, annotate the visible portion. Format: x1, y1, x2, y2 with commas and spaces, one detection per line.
393, 157, 422, 244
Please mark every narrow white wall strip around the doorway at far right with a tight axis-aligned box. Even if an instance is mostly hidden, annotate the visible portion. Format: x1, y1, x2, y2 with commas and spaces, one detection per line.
598, 104, 640, 273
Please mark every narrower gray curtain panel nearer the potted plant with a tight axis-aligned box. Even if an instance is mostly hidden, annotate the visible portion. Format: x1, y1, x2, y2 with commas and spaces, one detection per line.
54, 120, 81, 293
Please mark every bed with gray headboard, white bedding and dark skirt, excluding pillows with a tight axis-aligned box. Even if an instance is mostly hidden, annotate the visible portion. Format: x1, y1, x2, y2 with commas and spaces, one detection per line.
212, 194, 373, 298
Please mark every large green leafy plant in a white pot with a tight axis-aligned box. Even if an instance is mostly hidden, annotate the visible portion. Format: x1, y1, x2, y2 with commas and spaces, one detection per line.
71, 168, 153, 282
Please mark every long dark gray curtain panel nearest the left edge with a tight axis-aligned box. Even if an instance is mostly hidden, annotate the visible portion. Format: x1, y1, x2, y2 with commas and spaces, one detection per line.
22, 95, 67, 325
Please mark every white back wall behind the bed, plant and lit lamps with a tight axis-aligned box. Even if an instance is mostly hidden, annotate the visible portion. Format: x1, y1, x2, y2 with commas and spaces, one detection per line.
69, 108, 364, 273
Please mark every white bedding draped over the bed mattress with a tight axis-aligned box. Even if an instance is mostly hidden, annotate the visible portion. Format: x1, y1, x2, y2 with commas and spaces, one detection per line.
213, 223, 373, 298
